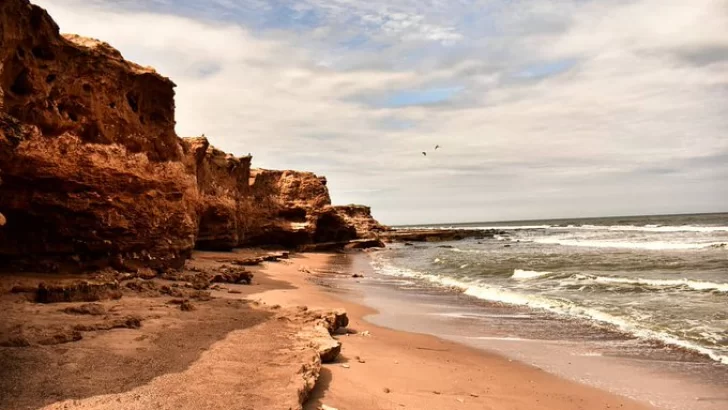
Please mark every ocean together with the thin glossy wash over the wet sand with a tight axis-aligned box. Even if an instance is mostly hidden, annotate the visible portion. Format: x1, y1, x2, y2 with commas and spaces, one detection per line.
326, 214, 728, 410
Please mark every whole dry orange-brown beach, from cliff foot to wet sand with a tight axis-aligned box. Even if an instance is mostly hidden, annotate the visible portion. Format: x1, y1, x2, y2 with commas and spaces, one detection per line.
0, 251, 647, 410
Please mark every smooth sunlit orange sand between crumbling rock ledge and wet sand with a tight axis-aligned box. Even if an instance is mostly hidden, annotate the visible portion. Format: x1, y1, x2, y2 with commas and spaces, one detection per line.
246, 254, 651, 410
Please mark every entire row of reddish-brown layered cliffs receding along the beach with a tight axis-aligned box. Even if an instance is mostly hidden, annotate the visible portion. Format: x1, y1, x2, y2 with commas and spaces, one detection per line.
0, 0, 386, 271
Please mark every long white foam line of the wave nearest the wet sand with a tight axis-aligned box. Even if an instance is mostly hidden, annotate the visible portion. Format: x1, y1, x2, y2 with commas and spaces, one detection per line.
378, 265, 728, 364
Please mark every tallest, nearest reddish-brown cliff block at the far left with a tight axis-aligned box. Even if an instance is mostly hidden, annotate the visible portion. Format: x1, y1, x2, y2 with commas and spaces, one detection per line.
0, 0, 197, 270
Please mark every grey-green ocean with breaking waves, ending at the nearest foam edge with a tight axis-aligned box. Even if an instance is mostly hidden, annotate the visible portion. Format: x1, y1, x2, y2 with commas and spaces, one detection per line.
373, 213, 728, 365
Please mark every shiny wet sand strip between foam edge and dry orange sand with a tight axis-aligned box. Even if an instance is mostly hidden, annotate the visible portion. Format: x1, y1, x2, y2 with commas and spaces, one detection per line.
323, 251, 728, 410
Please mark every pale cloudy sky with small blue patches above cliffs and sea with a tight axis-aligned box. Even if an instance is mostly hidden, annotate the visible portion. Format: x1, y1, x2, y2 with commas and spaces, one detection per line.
33, 0, 728, 224
